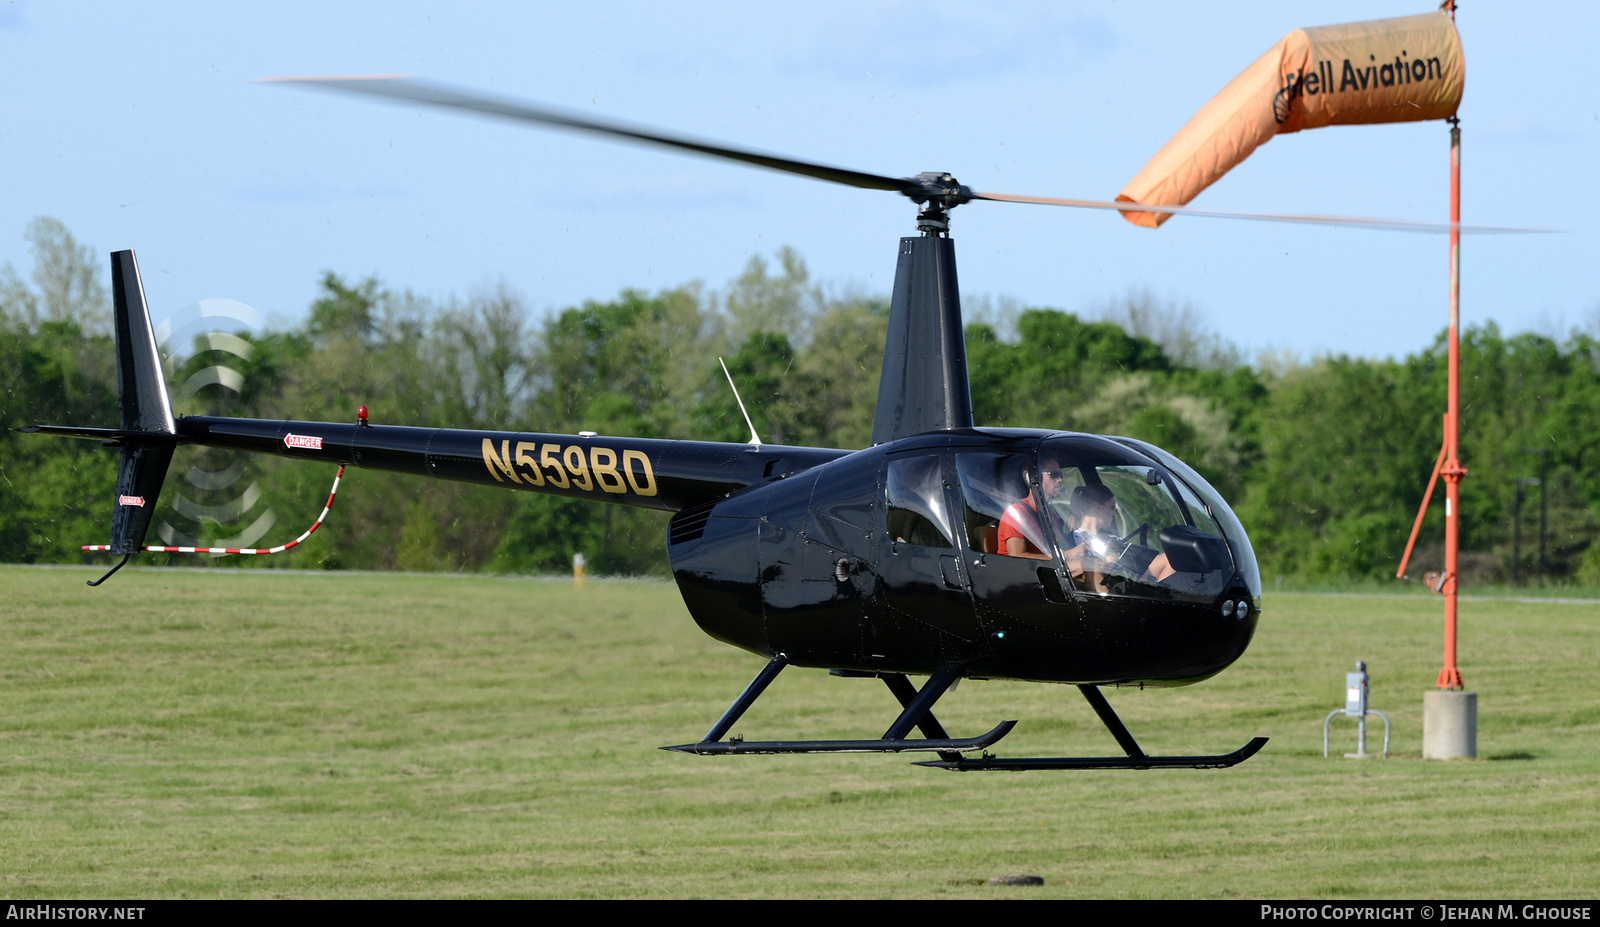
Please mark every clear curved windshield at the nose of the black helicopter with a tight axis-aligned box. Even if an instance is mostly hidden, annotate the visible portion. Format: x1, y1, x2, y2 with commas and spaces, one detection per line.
1038, 435, 1234, 602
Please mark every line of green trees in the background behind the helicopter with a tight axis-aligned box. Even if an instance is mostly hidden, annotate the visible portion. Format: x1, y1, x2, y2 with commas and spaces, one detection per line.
0, 218, 1600, 584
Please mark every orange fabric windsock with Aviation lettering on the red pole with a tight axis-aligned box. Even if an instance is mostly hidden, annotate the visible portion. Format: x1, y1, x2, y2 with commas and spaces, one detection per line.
1117, 11, 1466, 229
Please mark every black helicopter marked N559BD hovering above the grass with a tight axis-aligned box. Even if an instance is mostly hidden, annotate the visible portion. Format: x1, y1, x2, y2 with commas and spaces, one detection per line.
34, 78, 1472, 770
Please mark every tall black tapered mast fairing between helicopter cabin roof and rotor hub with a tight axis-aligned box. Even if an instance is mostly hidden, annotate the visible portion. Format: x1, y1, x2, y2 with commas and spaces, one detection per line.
872, 235, 973, 445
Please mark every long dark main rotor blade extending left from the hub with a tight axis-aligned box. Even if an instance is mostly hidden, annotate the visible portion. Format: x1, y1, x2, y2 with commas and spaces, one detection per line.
258, 75, 922, 197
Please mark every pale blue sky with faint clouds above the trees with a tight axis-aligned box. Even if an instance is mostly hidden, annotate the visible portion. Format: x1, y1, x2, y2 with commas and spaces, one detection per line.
0, 0, 1600, 359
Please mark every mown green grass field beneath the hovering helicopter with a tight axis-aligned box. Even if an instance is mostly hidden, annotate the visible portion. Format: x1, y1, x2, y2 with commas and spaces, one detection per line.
0, 567, 1600, 900
